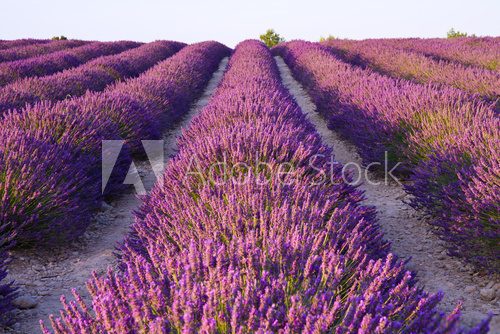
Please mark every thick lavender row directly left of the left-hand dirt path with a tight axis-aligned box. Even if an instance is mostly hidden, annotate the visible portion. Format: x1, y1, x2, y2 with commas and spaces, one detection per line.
0, 42, 230, 324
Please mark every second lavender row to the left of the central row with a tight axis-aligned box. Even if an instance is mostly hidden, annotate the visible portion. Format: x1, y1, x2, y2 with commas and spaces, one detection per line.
0, 41, 185, 115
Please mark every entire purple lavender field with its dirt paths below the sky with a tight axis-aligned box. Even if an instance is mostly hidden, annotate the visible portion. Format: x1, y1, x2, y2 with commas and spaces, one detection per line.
0, 37, 500, 334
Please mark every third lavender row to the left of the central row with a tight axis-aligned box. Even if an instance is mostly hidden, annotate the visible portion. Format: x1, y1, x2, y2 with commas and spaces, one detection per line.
0, 41, 140, 86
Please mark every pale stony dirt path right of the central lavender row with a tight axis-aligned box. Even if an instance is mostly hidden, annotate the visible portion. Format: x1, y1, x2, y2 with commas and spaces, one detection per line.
275, 57, 500, 333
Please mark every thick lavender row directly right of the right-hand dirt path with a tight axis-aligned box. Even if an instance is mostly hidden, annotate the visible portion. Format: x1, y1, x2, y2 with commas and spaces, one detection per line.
275, 41, 500, 271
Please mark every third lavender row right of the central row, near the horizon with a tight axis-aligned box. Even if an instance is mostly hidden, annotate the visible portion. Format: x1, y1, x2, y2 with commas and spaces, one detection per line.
375, 37, 500, 71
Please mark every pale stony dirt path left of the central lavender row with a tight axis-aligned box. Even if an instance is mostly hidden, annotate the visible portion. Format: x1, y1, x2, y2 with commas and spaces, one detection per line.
0, 58, 228, 334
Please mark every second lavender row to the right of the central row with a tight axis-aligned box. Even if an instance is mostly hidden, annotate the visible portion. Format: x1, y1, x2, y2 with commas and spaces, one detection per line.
325, 39, 500, 101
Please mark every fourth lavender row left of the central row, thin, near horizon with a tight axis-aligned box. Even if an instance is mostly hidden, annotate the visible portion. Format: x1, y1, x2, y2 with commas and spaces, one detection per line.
0, 40, 89, 63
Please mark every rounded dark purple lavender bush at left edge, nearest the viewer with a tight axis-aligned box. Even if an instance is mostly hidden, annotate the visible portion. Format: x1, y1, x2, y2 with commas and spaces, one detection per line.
0, 127, 100, 245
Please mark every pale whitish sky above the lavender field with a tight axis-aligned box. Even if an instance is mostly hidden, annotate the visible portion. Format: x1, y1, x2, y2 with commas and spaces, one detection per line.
0, 0, 500, 47
